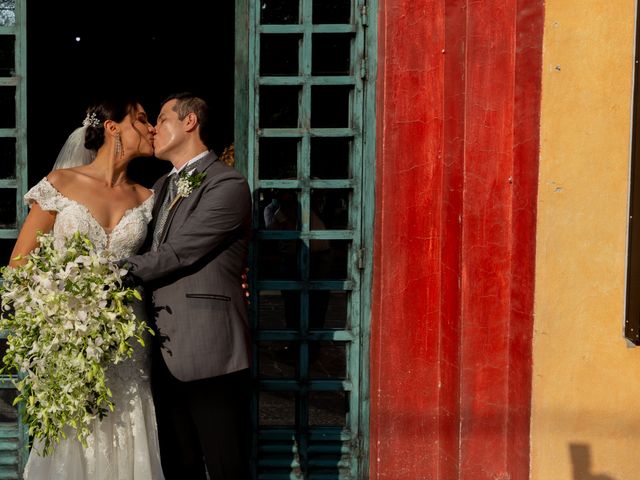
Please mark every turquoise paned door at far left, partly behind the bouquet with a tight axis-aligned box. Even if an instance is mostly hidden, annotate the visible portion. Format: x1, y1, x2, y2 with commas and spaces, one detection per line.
0, 0, 27, 479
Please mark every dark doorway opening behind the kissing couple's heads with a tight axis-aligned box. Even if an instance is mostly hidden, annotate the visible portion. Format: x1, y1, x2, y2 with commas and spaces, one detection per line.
27, 0, 234, 186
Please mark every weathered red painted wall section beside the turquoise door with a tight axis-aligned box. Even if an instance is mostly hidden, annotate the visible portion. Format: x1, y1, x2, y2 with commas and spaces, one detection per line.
370, 0, 543, 480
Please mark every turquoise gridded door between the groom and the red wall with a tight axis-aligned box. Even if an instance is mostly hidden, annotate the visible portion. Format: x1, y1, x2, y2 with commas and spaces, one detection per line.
236, 0, 372, 480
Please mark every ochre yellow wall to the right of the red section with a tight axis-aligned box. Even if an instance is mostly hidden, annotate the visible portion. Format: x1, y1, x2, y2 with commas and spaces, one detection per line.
531, 0, 640, 480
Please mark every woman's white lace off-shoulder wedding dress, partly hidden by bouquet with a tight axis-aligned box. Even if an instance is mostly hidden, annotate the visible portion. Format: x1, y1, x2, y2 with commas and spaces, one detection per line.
24, 178, 163, 480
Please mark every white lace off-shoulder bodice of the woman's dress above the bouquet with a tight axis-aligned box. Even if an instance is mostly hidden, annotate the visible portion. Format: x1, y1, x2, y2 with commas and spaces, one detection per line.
24, 177, 153, 258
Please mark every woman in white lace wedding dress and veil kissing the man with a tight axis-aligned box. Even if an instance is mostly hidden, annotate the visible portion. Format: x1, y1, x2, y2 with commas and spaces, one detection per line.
9, 95, 163, 480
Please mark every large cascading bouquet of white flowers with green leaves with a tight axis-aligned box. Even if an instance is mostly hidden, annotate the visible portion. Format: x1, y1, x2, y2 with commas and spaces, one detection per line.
0, 233, 151, 454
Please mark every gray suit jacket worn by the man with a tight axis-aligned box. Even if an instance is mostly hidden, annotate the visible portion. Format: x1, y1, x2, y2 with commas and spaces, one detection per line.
126, 152, 251, 381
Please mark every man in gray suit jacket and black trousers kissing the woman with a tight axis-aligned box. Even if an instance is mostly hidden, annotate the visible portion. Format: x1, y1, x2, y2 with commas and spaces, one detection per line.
125, 93, 251, 480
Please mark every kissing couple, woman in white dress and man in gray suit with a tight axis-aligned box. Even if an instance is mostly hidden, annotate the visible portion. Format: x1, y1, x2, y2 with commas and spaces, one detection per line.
10, 93, 251, 480
